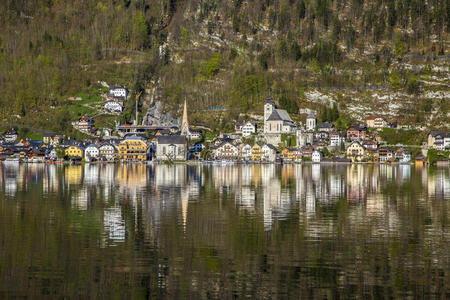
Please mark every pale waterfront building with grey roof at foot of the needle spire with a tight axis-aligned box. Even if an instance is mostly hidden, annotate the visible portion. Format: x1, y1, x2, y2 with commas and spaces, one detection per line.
155, 135, 187, 160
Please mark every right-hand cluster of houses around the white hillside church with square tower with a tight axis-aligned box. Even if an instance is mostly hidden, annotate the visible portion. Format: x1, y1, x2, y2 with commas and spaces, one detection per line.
206, 97, 428, 162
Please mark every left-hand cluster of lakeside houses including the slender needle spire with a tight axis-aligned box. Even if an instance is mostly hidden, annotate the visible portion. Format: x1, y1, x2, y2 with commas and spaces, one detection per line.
0, 99, 199, 162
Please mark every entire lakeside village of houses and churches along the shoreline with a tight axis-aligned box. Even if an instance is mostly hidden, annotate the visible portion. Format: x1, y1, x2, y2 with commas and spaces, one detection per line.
0, 85, 450, 166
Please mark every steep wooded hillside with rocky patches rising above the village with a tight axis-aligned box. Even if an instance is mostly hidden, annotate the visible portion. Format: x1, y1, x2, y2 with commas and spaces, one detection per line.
0, 0, 450, 131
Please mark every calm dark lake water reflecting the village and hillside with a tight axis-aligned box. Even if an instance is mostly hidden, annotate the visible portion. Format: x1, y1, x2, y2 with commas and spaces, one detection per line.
0, 163, 450, 299
